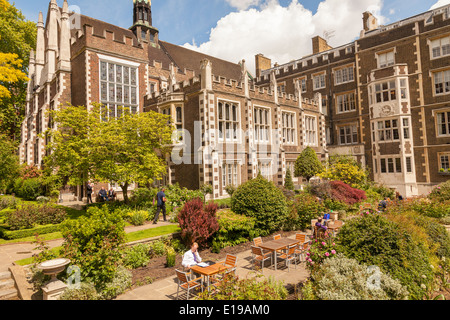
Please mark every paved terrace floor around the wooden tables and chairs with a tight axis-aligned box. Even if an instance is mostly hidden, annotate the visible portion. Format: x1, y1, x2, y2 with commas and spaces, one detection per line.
116, 236, 309, 300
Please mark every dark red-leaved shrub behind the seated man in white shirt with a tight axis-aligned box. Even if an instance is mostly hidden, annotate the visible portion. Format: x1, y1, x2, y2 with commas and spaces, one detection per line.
178, 198, 219, 247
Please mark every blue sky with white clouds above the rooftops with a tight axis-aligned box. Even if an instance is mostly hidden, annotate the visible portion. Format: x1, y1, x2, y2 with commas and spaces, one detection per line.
10, 0, 450, 73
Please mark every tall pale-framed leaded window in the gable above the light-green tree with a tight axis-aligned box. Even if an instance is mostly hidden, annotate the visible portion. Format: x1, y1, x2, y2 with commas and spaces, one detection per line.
100, 61, 139, 118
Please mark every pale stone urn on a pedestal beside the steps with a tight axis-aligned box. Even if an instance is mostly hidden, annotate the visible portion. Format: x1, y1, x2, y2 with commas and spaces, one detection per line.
37, 259, 70, 300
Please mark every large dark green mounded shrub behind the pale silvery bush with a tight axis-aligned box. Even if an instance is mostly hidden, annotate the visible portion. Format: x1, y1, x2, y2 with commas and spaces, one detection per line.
336, 214, 433, 299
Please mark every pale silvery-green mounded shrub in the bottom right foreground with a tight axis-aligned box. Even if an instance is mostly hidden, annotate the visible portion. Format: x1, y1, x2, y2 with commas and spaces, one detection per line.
313, 254, 408, 300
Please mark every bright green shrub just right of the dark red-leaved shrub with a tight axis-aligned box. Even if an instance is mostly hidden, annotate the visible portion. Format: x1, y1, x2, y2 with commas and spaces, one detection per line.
212, 210, 256, 253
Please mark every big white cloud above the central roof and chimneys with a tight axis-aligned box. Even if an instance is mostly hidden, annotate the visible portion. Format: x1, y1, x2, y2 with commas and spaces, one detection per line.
184, 0, 385, 73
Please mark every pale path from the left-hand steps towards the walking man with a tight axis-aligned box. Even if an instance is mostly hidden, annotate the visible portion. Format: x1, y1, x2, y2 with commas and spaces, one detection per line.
0, 222, 173, 272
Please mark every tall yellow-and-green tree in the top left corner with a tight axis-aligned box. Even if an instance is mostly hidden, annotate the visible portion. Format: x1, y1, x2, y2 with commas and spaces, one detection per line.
0, 0, 37, 139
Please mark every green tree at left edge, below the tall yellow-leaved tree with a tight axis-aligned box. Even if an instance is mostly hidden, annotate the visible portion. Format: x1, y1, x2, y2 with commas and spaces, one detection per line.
0, 134, 19, 192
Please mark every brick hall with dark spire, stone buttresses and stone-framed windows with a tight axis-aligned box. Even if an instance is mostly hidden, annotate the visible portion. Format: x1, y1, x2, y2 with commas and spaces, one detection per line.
19, 0, 327, 199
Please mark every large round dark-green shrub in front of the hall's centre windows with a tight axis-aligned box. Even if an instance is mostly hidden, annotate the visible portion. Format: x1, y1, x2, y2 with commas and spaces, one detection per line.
231, 175, 288, 236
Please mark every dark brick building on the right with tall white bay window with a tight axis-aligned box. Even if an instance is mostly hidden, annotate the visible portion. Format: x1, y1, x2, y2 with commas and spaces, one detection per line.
255, 6, 450, 196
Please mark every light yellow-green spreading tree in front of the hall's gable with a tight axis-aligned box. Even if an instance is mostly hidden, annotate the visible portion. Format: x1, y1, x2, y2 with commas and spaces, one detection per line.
45, 104, 173, 202
